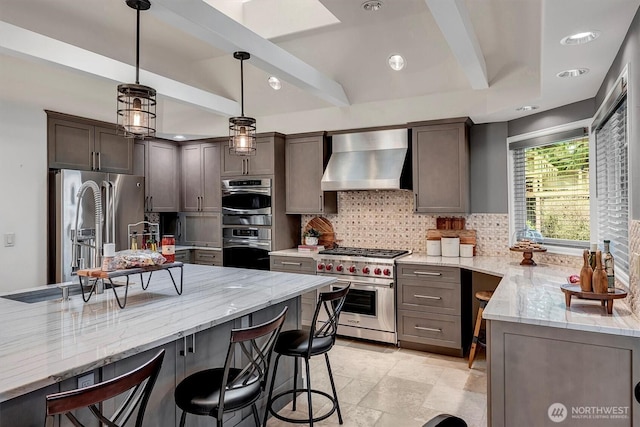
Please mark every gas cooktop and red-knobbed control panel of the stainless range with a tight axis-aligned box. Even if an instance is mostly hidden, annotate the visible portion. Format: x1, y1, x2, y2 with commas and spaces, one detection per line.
316, 247, 410, 279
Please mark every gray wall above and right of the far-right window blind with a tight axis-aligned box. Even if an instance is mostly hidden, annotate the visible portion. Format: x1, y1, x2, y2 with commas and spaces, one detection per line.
595, 8, 640, 219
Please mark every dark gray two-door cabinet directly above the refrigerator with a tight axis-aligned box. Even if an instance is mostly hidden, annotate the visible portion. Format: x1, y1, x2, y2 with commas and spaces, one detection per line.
47, 111, 134, 174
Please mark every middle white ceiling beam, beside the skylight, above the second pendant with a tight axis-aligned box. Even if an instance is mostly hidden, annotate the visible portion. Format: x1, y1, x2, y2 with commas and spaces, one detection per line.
149, 0, 349, 107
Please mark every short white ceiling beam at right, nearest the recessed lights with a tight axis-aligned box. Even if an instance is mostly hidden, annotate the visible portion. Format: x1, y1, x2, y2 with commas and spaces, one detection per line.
424, 0, 489, 89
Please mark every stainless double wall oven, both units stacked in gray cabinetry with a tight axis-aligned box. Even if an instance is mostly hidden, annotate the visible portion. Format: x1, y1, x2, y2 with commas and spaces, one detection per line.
222, 178, 272, 270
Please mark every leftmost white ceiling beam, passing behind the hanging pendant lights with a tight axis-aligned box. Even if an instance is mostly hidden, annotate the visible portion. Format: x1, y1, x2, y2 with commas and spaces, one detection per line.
0, 21, 240, 116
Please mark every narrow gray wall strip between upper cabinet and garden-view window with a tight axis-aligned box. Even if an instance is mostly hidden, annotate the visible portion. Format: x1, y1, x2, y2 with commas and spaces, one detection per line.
469, 122, 508, 213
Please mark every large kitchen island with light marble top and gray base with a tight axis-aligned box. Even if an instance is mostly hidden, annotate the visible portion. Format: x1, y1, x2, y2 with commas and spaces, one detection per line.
0, 264, 334, 426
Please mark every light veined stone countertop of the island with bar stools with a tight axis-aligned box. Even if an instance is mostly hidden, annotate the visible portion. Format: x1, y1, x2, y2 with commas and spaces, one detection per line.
0, 264, 335, 402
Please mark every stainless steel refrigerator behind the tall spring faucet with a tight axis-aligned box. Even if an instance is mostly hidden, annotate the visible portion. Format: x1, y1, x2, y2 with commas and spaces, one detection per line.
49, 169, 144, 283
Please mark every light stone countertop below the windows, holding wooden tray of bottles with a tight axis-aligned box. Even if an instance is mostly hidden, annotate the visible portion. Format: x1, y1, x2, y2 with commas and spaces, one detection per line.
396, 254, 640, 337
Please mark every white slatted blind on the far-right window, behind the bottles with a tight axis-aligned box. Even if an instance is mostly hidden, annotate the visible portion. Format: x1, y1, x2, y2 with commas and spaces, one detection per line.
595, 96, 629, 275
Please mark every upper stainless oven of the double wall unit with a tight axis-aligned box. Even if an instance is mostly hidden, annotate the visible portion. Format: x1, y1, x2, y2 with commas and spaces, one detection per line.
222, 178, 271, 225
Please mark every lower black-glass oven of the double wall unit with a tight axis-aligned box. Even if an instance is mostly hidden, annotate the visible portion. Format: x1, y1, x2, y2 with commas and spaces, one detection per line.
222, 227, 271, 270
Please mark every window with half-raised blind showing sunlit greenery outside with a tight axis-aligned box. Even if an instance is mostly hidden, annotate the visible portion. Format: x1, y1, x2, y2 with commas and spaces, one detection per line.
509, 127, 590, 248
